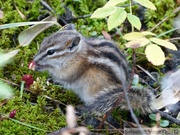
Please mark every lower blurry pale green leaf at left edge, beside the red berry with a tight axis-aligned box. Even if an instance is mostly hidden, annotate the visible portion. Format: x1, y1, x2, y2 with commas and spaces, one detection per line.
0, 81, 13, 98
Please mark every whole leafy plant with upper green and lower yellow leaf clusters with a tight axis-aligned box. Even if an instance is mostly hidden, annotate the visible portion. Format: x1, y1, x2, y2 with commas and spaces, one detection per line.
91, 0, 177, 66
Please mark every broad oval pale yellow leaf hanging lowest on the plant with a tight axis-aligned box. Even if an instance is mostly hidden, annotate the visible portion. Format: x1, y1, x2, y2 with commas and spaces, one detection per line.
145, 44, 165, 66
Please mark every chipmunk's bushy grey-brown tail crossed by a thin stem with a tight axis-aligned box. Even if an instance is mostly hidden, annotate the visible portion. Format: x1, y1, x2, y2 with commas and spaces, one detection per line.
85, 88, 154, 115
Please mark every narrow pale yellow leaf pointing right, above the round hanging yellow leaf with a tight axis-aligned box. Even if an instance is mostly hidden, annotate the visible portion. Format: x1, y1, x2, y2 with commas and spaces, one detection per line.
150, 38, 177, 51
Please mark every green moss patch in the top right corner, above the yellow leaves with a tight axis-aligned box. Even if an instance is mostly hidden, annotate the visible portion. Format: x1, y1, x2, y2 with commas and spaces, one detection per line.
145, 0, 178, 38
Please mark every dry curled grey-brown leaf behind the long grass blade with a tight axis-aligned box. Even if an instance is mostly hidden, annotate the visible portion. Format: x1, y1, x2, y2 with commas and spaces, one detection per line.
18, 16, 57, 46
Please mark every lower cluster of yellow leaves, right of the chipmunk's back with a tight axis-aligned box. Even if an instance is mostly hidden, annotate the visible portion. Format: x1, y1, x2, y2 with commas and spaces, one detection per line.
123, 31, 177, 66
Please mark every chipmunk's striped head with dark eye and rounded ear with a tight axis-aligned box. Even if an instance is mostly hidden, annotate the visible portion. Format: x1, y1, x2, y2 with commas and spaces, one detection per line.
34, 24, 87, 80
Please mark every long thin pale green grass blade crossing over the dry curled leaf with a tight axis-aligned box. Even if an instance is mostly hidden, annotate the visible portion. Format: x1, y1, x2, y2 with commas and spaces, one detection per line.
0, 21, 58, 29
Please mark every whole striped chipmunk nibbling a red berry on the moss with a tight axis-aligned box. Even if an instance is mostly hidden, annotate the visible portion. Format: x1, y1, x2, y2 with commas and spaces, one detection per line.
34, 24, 153, 115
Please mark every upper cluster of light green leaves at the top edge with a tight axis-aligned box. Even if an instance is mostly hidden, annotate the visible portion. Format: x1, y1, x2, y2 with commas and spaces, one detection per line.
91, 0, 156, 30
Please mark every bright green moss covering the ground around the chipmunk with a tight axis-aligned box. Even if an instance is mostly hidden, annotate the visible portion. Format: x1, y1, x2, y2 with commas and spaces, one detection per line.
0, 0, 179, 135
